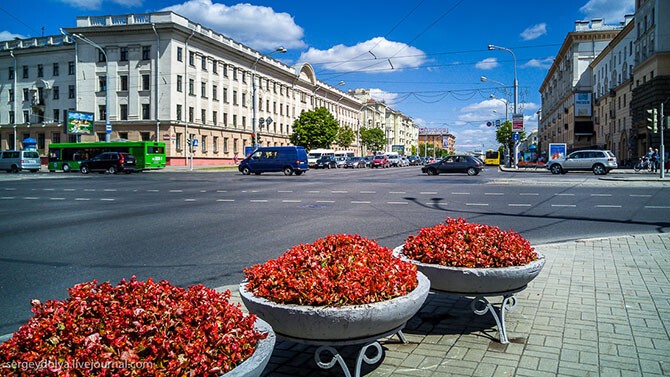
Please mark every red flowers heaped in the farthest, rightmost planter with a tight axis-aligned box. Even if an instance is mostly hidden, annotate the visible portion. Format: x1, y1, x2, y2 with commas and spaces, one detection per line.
403, 218, 537, 268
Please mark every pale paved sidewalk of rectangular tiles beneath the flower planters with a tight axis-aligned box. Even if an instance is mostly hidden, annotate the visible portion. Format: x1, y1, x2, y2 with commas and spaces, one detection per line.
220, 234, 670, 377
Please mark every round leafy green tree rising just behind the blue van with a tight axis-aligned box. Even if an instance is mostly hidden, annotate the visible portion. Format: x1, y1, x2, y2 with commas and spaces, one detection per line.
289, 107, 340, 150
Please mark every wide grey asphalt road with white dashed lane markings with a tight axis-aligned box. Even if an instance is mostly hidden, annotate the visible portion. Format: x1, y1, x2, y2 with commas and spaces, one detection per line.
0, 167, 670, 335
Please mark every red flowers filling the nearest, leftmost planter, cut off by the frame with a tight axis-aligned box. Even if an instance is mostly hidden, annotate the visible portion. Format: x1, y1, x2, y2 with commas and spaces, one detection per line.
0, 277, 267, 376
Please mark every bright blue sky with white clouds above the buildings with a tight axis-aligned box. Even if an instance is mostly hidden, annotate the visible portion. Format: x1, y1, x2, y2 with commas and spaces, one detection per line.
0, 0, 635, 150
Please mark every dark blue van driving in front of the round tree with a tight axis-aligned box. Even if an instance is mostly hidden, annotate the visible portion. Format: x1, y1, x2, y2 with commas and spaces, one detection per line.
238, 146, 309, 175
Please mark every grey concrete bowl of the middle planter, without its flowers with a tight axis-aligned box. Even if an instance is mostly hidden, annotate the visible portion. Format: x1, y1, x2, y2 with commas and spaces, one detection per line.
239, 273, 430, 341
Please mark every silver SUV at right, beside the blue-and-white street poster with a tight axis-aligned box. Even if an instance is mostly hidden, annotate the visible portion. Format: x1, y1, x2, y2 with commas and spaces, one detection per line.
546, 150, 618, 175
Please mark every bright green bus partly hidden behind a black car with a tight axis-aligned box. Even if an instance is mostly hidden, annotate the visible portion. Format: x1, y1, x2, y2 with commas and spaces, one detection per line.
49, 141, 165, 173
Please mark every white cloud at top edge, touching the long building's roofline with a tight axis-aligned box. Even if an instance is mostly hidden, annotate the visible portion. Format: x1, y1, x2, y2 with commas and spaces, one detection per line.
163, 0, 305, 50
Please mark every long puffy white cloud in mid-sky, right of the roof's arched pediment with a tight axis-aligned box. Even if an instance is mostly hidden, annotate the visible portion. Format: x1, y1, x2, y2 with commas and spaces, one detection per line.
299, 37, 426, 72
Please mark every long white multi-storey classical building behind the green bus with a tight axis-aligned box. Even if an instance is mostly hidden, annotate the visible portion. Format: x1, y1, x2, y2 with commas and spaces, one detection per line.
0, 11, 378, 165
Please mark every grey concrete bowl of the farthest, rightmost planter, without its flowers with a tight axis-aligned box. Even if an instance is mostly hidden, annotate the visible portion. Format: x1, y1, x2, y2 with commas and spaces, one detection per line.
393, 245, 544, 295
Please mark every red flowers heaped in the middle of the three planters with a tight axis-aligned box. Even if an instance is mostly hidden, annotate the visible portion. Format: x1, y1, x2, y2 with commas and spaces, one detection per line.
244, 234, 418, 306
